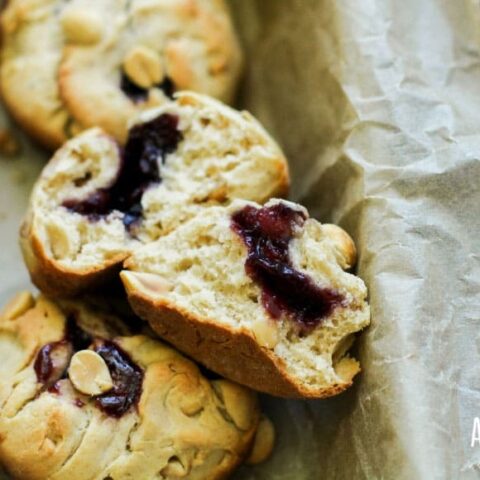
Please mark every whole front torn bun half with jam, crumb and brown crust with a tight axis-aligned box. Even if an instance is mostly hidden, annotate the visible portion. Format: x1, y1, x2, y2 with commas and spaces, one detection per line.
121, 200, 370, 398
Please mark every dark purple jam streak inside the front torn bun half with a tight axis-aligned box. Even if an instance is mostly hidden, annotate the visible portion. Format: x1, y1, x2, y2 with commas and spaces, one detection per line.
232, 203, 344, 328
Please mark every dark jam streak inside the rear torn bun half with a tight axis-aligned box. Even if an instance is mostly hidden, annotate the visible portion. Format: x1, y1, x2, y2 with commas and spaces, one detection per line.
63, 113, 183, 228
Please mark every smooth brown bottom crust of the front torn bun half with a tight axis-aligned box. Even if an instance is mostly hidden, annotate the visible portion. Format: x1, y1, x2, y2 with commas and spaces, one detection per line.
125, 284, 354, 398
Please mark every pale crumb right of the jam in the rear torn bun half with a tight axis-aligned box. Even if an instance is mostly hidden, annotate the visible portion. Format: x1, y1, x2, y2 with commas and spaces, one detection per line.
140, 93, 289, 242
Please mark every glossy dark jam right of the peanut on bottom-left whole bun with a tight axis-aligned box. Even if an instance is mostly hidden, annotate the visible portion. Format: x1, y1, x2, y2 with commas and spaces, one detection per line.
95, 341, 143, 418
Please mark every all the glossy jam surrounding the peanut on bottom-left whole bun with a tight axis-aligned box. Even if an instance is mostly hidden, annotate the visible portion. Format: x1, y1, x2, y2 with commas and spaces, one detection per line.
33, 316, 143, 418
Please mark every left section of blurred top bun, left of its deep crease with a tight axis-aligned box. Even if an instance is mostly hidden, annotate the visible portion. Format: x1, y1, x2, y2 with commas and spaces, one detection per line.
0, 0, 75, 149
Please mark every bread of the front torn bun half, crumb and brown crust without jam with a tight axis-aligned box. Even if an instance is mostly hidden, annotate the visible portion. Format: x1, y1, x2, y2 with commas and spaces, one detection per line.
122, 200, 370, 397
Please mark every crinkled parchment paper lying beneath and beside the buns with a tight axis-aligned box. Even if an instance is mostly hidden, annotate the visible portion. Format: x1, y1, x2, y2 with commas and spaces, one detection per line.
0, 0, 480, 480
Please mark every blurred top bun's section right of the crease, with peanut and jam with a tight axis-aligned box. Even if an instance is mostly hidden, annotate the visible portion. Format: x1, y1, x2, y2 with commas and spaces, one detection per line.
58, 0, 246, 143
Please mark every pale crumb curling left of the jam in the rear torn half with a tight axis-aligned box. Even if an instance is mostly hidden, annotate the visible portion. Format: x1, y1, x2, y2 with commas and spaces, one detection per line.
24, 129, 138, 270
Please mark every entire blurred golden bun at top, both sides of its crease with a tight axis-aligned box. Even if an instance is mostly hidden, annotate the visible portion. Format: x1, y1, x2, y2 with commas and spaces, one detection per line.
0, 0, 242, 149
